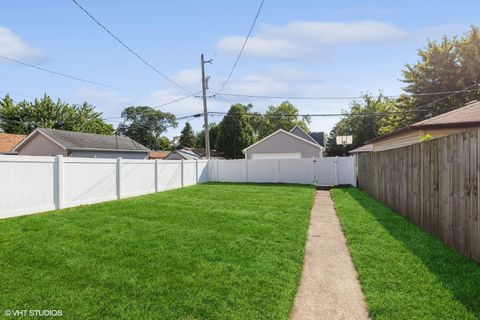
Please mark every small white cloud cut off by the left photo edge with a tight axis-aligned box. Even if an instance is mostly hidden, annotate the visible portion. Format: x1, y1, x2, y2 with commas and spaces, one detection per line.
0, 27, 45, 61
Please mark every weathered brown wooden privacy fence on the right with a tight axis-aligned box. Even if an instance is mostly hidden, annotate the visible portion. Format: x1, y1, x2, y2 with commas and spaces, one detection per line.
358, 129, 480, 262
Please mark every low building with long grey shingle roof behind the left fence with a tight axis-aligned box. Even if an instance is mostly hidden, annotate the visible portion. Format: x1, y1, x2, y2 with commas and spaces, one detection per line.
14, 128, 150, 159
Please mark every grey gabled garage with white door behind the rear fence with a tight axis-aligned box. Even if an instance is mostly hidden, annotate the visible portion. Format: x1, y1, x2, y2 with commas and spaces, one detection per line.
243, 126, 324, 159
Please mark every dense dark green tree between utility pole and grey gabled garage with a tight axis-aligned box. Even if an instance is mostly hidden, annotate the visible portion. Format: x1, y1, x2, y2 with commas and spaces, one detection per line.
217, 103, 255, 159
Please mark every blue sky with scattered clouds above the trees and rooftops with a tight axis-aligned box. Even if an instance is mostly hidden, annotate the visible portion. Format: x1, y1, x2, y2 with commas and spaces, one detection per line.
0, 0, 480, 137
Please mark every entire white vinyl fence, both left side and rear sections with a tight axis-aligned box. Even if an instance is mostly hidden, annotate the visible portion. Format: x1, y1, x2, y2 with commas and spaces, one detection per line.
0, 156, 356, 219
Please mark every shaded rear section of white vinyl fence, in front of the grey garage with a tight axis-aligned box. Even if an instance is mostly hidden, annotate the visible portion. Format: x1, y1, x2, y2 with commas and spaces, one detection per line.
209, 157, 357, 186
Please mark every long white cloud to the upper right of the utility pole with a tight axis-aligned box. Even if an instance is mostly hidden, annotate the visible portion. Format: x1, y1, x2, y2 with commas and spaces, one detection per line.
217, 21, 410, 59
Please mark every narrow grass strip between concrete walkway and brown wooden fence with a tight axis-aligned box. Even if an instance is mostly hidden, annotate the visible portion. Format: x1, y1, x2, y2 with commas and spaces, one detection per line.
332, 188, 480, 319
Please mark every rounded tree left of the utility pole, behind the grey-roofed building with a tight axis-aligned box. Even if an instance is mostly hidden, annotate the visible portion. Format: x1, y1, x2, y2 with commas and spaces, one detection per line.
117, 106, 177, 149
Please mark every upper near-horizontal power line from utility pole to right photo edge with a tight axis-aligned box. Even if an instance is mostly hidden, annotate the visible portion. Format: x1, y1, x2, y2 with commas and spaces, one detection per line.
212, 86, 479, 100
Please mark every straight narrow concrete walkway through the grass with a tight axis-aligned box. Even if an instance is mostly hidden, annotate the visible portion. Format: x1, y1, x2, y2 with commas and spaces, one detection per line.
290, 191, 369, 320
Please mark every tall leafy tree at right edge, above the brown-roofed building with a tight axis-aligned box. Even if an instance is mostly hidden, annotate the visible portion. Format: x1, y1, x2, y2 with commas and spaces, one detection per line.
403, 26, 480, 124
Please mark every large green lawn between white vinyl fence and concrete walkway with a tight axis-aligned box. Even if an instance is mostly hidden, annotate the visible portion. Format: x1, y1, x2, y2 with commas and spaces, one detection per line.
0, 184, 314, 319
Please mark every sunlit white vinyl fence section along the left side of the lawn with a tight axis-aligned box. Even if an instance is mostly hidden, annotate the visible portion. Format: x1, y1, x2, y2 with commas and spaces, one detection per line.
0, 156, 208, 218
